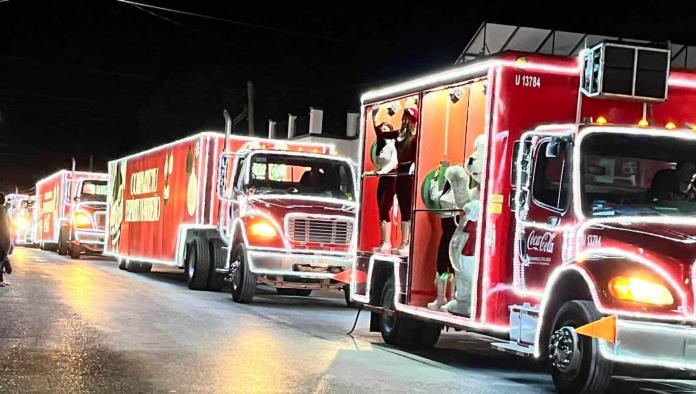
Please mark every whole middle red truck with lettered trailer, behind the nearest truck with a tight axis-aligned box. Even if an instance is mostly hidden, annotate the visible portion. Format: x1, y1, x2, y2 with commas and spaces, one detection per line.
106, 121, 356, 302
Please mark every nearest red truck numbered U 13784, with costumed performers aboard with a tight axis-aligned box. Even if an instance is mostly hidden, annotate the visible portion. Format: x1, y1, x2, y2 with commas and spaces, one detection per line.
351, 42, 696, 392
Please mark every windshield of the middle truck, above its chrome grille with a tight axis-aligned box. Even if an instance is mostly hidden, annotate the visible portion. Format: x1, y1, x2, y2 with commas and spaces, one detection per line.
245, 153, 355, 201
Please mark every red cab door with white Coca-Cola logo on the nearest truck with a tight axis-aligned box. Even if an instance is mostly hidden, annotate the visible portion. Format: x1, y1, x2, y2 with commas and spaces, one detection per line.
514, 133, 574, 291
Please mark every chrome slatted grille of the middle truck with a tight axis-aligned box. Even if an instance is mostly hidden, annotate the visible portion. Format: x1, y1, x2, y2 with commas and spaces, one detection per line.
288, 218, 353, 244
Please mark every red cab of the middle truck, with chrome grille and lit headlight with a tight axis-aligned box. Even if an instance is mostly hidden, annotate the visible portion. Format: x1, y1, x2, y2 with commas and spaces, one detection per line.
216, 150, 357, 303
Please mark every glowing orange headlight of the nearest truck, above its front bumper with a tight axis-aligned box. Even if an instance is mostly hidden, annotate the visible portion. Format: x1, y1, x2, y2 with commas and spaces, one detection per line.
609, 276, 674, 306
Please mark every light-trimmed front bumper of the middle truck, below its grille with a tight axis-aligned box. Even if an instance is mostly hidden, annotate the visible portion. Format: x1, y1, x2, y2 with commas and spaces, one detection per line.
247, 249, 353, 279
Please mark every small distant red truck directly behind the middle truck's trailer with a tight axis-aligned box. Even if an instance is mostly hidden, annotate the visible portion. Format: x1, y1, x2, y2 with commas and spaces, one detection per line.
34, 170, 107, 259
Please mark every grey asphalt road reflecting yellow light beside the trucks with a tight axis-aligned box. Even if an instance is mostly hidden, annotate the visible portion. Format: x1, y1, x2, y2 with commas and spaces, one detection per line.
0, 248, 696, 393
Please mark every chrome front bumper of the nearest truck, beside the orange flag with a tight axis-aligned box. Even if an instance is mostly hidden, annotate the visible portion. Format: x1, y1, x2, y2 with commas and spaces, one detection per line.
600, 319, 696, 370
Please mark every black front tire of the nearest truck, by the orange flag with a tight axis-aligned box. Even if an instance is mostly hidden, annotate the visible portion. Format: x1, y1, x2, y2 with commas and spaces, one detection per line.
548, 301, 614, 394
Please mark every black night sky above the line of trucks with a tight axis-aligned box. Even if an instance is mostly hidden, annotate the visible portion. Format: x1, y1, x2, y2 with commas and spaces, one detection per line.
0, 0, 696, 191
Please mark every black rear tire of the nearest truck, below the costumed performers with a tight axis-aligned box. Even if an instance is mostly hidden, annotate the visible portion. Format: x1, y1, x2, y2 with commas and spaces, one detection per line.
379, 277, 442, 349
